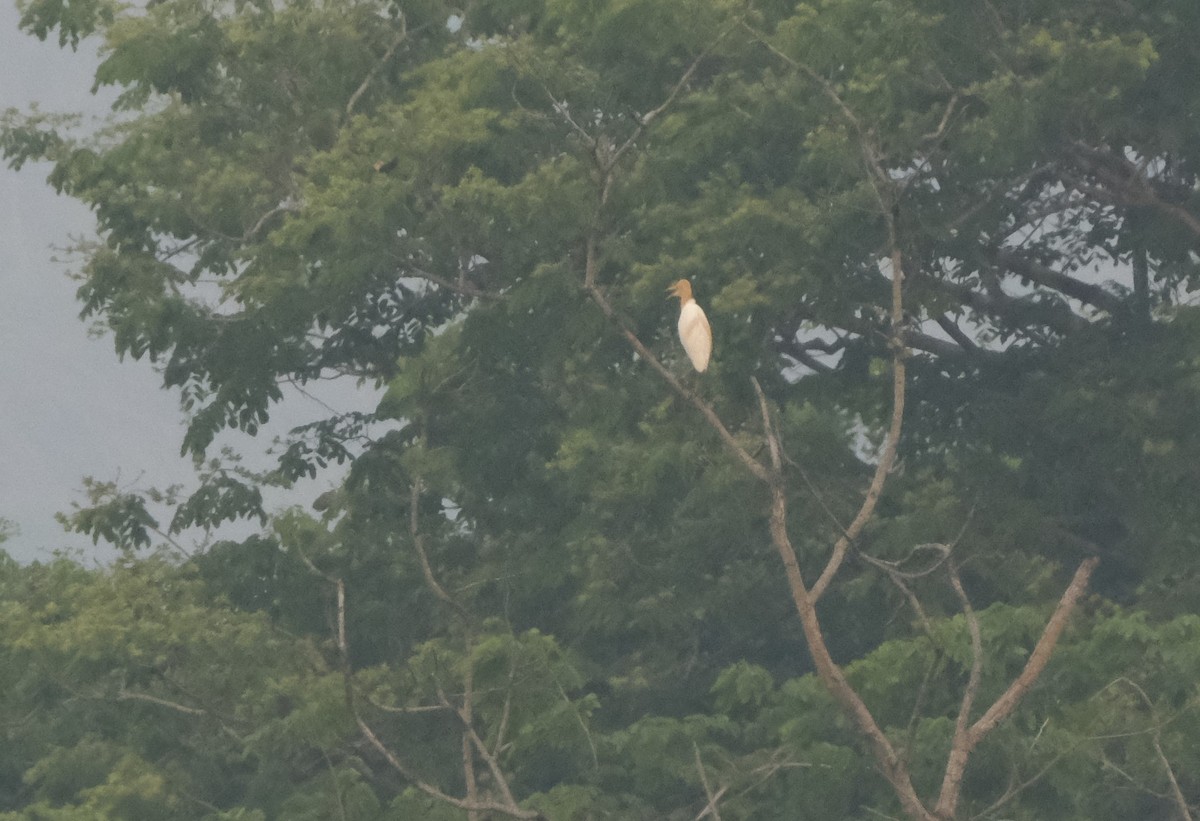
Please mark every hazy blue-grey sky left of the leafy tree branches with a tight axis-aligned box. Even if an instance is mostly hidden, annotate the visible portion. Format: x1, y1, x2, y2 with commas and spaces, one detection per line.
0, 0, 368, 561
